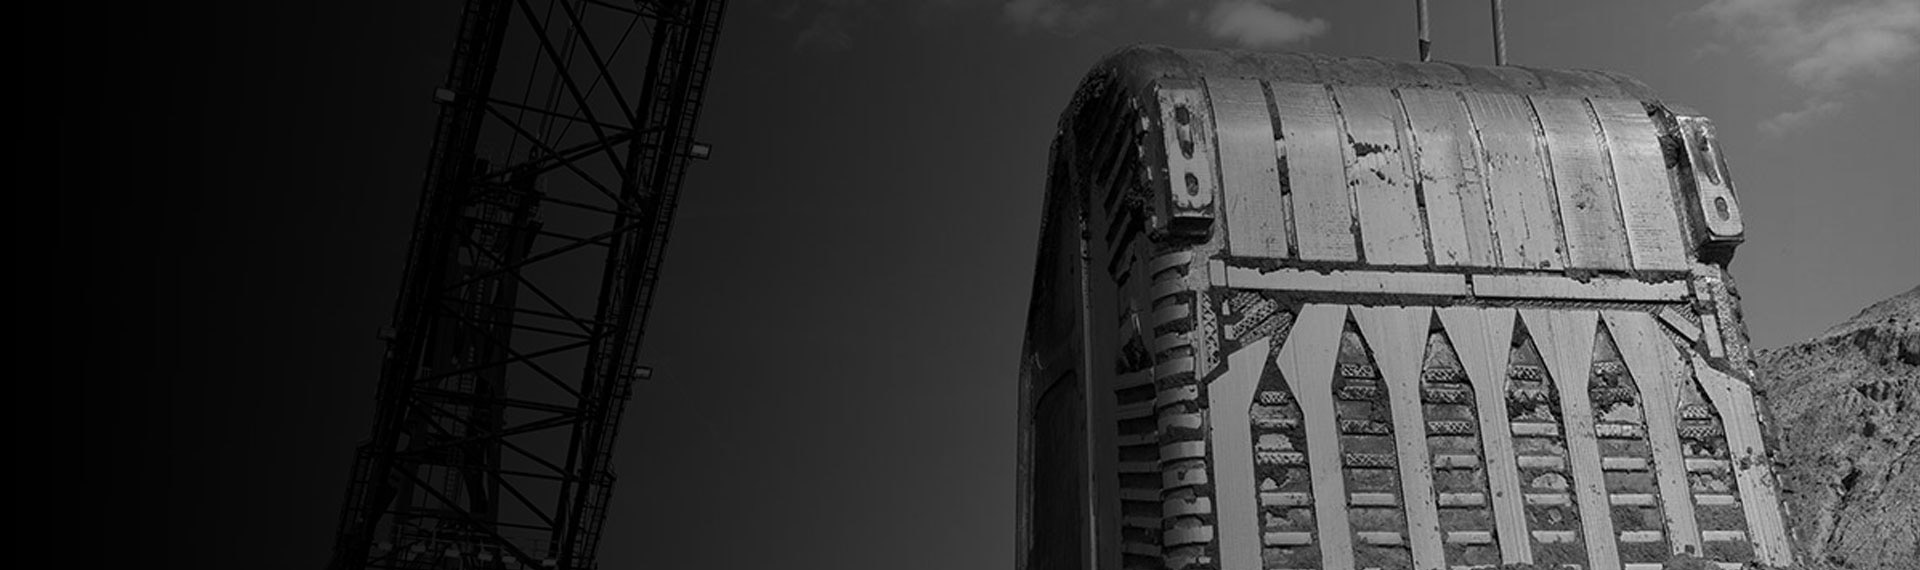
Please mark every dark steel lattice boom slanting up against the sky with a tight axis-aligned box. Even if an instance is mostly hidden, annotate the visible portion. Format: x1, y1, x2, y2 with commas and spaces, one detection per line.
328, 0, 726, 570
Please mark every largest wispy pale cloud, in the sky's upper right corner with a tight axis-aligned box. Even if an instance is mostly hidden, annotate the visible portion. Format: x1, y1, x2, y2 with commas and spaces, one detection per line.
1699, 0, 1920, 134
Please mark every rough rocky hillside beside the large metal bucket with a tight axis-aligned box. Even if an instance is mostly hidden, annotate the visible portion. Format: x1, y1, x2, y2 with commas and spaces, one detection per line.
1757, 288, 1920, 570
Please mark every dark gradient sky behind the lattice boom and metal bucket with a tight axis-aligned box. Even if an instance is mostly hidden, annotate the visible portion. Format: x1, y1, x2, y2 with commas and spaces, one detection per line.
63, 0, 1920, 568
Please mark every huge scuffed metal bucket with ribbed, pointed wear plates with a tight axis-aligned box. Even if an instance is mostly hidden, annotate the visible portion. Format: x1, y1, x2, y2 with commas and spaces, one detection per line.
1020, 48, 1791, 570
